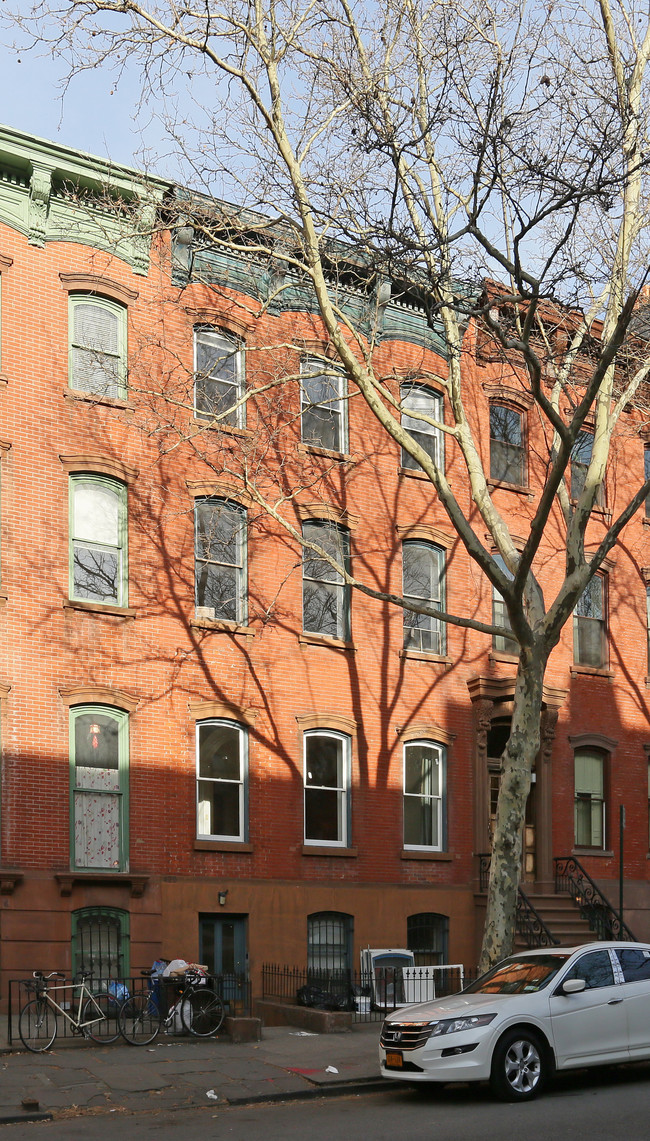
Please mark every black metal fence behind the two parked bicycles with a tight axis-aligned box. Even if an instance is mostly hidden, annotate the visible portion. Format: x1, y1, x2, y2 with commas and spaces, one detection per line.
7, 971, 252, 1045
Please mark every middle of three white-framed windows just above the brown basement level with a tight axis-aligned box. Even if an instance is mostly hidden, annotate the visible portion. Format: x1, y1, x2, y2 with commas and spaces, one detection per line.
303, 729, 350, 848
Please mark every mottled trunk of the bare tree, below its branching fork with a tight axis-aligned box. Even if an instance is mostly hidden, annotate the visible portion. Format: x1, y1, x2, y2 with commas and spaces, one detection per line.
479, 647, 546, 971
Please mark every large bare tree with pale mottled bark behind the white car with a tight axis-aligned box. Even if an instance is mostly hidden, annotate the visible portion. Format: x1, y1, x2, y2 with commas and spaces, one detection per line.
11, 0, 650, 966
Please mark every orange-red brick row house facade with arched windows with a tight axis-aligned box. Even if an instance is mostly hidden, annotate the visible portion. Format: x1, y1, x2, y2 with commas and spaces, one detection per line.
0, 120, 650, 993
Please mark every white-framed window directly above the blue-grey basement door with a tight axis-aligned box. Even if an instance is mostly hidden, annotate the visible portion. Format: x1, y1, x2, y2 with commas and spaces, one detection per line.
196, 720, 249, 840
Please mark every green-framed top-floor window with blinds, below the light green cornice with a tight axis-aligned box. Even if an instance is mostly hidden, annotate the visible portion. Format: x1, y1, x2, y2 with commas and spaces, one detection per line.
68, 293, 127, 399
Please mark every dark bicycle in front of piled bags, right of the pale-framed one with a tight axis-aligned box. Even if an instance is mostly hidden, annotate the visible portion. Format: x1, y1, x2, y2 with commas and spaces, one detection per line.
117, 971, 226, 1046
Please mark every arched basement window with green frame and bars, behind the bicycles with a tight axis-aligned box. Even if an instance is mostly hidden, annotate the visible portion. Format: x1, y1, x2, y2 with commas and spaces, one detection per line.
72, 907, 130, 986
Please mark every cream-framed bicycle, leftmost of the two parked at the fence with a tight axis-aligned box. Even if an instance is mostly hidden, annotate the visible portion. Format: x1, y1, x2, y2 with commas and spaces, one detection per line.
18, 971, 120, 1054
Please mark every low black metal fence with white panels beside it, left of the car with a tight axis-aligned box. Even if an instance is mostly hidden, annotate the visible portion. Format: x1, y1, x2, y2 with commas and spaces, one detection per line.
262, 963, 473, 1022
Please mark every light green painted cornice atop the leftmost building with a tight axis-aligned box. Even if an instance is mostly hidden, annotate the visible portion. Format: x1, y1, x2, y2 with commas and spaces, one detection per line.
0, 126, 171, 274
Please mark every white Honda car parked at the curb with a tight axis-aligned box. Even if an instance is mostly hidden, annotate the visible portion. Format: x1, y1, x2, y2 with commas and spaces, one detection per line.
380, 942, 650, 1101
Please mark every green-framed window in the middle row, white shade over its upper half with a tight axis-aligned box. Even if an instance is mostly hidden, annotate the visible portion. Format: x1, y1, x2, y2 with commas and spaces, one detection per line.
70, 475, 128, 606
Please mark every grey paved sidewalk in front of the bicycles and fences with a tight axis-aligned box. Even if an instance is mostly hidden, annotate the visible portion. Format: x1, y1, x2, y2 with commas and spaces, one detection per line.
0, 1019, 388, 1124
